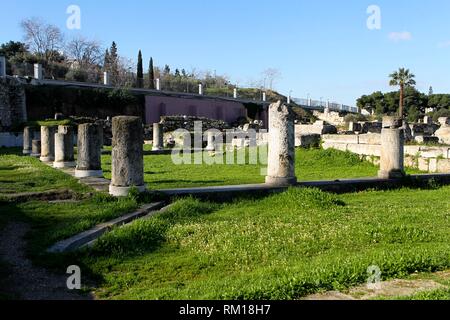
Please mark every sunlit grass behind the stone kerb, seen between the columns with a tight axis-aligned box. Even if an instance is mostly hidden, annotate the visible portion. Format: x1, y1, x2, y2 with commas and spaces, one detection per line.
102, 149, 418, 189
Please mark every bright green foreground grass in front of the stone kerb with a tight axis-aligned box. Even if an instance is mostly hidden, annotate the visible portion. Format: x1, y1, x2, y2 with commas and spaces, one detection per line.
61, 187, 450, 299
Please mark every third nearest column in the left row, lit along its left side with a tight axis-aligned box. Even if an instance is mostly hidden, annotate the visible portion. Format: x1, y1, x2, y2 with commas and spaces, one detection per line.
53, 126, 76, 168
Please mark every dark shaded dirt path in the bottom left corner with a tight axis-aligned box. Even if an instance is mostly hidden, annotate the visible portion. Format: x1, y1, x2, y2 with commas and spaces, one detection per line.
0, 222, 92, 300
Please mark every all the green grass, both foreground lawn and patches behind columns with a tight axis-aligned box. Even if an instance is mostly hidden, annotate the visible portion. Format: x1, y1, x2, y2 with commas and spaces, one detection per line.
0, 150, 444, 299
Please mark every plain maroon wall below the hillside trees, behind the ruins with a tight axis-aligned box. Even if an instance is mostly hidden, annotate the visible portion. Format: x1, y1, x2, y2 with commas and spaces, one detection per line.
145, 96, 247, 124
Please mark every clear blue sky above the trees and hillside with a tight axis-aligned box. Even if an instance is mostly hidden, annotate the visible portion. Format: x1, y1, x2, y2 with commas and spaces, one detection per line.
0, 0, 450, 105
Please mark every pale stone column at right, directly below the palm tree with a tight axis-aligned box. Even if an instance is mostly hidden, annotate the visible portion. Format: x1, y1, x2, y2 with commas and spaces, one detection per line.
378, 117, 405, 179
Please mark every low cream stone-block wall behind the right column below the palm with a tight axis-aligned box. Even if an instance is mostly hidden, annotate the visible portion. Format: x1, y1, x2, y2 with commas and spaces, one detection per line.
322, 133, 450, 173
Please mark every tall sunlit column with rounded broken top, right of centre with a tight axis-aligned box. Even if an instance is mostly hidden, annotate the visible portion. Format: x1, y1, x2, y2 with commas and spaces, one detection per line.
266, 101, 297, 185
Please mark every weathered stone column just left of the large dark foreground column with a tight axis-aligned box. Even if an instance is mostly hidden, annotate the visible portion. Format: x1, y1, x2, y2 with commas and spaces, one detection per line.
75, 123, 103, 178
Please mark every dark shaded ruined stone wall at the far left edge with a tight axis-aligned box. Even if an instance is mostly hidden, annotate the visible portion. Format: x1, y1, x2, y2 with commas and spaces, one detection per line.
0, 78, 27, 131
